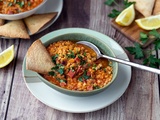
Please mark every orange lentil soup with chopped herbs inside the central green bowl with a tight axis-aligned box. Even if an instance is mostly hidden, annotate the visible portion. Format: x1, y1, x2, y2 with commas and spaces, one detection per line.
43, 40, 113, 91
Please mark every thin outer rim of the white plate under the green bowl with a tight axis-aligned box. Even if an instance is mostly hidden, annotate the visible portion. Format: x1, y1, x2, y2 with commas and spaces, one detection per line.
22, 28, 132, 113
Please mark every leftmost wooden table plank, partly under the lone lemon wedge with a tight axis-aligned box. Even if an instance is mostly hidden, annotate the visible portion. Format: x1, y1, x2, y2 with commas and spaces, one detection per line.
0, 39, 19, 120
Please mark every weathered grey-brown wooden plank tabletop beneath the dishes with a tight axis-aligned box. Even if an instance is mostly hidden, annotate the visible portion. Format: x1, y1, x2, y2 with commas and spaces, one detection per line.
0, 0, 160, 120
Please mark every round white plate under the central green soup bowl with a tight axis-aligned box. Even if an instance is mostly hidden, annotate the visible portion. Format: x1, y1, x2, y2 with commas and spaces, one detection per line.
22, 28, 131, 113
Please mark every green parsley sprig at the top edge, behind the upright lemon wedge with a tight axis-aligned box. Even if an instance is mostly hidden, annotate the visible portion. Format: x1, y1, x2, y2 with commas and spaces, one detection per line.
104, 0, 135, 18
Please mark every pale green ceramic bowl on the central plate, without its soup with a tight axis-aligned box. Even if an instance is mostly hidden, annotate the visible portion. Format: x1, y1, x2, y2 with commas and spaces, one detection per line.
38, 33, 118, 96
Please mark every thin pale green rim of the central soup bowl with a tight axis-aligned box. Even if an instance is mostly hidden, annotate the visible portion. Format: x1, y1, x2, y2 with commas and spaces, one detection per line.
36, 32, 119, 94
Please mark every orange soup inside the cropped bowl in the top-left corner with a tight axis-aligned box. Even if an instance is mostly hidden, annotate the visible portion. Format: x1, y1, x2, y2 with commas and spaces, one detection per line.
0, 0, 43, 14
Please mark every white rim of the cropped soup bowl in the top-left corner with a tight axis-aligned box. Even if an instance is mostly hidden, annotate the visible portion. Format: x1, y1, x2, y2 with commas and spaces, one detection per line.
0, 0, 47, 19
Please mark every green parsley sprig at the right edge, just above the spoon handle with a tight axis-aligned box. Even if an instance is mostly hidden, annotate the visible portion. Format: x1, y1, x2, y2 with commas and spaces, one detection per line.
125, 29, 160, 68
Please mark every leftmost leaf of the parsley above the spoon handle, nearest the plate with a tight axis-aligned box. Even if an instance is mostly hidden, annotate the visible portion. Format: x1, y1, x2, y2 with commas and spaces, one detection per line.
125, 43, 144, 59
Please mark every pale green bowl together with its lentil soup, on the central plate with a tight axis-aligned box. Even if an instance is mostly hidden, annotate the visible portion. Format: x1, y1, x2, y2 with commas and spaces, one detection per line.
38, 33, 118, 96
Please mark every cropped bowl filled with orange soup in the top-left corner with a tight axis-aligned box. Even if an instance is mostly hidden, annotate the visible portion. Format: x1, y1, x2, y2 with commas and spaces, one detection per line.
0, 0, 47, 20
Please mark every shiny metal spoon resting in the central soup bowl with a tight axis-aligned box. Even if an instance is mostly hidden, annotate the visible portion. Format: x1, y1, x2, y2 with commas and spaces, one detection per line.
77, 41, 160, 74
